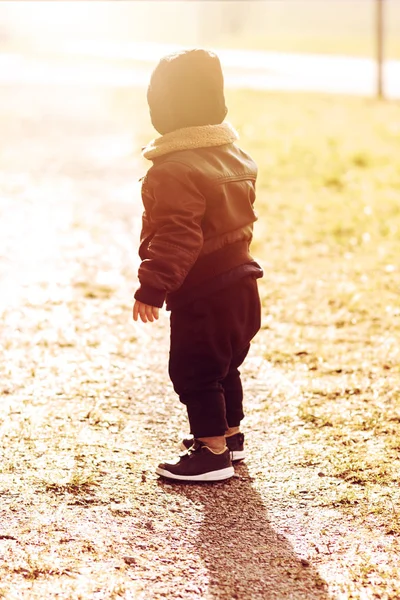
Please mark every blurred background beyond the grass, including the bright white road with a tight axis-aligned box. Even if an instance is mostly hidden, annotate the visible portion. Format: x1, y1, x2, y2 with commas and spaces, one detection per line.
0, 0, 400, 96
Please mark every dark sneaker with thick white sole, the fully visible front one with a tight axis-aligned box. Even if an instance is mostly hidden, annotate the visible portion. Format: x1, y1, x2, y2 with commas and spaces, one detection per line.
156, 440, 235, 481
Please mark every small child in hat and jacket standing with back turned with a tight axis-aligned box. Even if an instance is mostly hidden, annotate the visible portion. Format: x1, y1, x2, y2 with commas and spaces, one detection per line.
133, 50, 263, 481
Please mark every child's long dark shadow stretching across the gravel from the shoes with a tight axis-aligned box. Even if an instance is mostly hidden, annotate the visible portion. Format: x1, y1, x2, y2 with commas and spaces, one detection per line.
160, 465, 330, 600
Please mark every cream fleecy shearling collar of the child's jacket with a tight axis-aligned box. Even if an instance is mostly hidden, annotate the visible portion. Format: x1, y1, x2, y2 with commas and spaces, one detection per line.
142, 123, 239, 160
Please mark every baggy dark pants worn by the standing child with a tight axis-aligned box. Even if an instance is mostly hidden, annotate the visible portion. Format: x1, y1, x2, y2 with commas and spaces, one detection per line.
169, 277, 261, 437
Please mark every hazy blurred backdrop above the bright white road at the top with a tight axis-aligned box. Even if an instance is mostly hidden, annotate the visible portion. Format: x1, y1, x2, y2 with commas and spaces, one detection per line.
0, 0, 400, 58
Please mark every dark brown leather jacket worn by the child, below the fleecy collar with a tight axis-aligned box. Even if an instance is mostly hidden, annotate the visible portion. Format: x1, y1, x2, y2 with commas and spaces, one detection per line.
135, 143, 262, 308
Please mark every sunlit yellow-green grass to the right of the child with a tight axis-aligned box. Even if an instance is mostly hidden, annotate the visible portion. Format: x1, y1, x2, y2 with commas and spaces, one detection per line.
231, 89, 400, 598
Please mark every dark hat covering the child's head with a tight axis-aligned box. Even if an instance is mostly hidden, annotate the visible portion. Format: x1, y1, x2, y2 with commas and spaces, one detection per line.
147, 49, 228, 135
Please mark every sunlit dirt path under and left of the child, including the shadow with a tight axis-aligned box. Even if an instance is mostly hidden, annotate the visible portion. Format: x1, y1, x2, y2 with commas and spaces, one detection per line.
0, 81, 400, 600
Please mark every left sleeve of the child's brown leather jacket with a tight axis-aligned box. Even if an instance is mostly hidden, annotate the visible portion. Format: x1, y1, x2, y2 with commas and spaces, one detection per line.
135, 161, 205, 307
